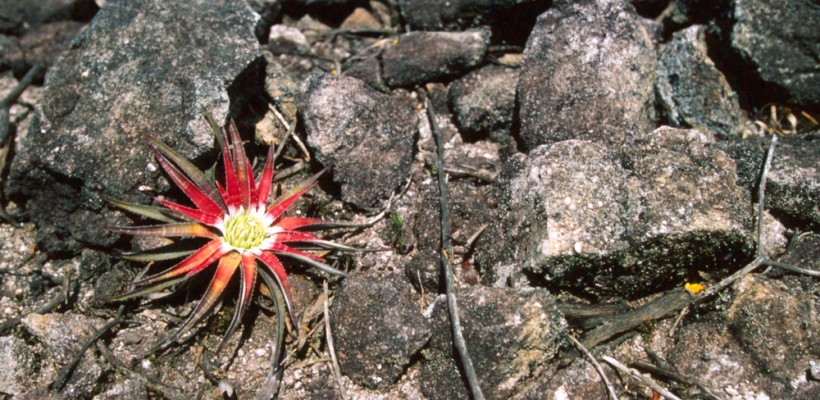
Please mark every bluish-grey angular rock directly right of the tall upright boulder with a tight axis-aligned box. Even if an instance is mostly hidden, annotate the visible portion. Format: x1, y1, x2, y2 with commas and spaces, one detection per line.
658, 25, 744, 136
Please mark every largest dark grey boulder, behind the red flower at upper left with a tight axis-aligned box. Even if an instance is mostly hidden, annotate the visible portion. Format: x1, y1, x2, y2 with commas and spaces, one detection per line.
7, 0, 258, 252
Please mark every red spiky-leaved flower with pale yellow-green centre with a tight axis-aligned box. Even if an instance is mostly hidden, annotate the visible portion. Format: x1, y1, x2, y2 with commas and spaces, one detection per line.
108, 116, 355, 351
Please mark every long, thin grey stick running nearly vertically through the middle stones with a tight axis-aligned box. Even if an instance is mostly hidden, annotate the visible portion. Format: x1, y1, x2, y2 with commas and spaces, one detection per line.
425, 98, 484, 400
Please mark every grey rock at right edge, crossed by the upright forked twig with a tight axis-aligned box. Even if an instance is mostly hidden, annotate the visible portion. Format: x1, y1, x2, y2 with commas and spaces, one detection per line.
718, 133, 820, 231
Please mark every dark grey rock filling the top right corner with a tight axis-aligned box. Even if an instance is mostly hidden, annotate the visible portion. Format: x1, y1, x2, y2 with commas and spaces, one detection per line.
731, 0, 820, 106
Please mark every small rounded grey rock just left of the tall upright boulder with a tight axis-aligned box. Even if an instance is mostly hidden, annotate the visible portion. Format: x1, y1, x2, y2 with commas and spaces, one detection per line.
449, 66, 518, 143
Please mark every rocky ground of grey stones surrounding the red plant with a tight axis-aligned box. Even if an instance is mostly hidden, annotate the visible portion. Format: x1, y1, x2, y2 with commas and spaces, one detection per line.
0, 0, 820, 400
